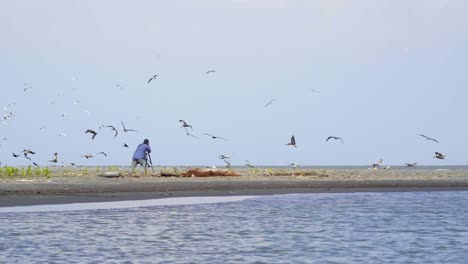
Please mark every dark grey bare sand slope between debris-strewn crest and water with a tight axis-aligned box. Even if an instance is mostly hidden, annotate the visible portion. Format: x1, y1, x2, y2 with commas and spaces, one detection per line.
0, 179, 468, 207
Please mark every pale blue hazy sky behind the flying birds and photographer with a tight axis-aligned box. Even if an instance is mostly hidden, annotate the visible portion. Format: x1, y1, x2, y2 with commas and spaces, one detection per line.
0, 0, 468, 165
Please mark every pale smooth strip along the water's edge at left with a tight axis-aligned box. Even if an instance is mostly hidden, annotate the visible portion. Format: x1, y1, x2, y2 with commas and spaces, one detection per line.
0, 196, 257, 213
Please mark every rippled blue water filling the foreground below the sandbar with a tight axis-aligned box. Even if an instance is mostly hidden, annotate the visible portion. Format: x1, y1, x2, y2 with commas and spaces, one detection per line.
0, 191, 468, 263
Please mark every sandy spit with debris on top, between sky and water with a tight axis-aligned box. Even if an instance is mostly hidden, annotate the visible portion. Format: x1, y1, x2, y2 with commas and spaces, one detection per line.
0, 168, 468, 207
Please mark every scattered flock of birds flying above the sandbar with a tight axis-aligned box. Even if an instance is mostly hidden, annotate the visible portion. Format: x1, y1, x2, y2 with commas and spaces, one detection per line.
0, 69, 445, 169
